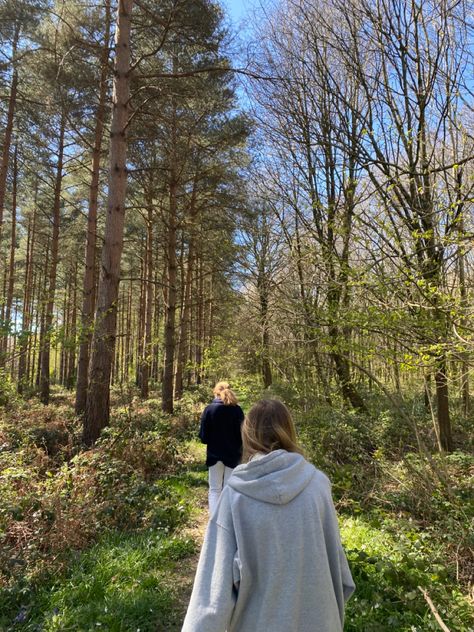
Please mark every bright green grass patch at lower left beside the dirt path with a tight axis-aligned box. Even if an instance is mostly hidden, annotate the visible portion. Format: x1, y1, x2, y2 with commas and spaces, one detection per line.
0, 531, 195, 632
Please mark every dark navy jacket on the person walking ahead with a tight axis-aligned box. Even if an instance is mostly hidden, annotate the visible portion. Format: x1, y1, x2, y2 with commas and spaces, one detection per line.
199, 397, 244, 467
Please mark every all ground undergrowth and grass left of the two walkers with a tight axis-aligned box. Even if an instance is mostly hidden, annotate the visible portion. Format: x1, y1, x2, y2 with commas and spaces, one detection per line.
0, 386, 207, 632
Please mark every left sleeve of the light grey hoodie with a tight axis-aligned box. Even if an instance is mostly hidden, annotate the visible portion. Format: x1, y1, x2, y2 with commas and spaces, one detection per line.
181, 503, 237, 632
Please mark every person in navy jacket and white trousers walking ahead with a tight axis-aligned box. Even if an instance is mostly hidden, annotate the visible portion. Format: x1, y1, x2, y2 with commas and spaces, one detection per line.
199, 382, 244, 514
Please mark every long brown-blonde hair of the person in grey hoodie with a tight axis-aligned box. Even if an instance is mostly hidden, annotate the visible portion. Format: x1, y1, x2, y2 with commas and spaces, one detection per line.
242, 399, 303, 461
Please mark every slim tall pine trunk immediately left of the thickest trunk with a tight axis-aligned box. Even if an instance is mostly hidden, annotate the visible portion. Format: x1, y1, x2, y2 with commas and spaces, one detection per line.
76, 0, 111, 415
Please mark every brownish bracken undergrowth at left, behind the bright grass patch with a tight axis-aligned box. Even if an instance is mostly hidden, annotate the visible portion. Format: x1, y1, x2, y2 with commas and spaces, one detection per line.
0, 405, 194, 630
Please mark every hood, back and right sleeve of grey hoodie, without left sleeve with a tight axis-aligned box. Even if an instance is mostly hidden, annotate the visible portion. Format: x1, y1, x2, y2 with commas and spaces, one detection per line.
221, 450, 352, 632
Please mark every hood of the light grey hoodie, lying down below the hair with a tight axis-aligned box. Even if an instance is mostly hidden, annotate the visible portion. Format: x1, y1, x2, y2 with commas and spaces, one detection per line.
227, 450, 316, 505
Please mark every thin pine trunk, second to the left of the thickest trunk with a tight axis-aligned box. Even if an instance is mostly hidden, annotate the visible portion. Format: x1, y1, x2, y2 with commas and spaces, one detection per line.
40, 112, 66, 404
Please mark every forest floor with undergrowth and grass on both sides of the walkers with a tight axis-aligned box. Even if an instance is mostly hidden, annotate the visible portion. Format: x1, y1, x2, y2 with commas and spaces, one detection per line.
0, 392, 474, 632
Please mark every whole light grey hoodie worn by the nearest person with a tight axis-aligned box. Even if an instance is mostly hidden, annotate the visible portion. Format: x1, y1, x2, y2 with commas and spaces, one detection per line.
182, 450, 354, 632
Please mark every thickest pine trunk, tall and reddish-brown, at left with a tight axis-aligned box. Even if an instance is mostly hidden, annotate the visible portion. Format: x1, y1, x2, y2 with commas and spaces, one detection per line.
82, 0, 133, 446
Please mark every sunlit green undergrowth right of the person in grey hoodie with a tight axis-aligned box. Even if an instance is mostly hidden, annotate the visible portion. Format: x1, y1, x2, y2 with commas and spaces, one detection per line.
294, 401, 474, 632
